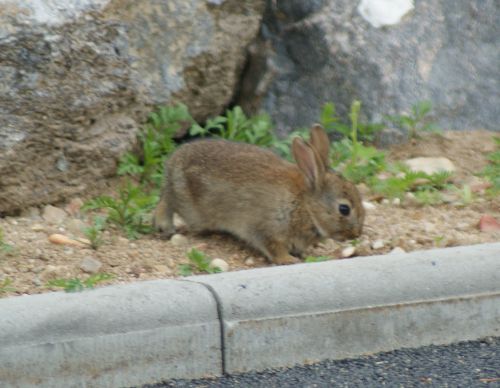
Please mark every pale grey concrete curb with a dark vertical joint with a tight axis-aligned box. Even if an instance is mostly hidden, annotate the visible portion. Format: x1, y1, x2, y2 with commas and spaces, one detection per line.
0, 243, 500, 387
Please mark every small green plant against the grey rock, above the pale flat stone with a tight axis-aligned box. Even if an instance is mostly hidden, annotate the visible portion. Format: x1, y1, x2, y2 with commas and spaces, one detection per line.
385, 101, 440, 139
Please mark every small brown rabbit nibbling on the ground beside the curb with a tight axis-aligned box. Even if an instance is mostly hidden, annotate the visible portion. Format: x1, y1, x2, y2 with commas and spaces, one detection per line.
154, 125, 365, 264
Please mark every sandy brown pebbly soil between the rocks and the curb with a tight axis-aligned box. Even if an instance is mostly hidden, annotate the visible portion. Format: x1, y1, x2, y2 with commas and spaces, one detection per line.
0, 131, 500, 297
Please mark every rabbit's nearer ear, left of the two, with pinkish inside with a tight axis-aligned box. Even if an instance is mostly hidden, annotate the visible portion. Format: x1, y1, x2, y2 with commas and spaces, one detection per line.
292, 137, 325, 190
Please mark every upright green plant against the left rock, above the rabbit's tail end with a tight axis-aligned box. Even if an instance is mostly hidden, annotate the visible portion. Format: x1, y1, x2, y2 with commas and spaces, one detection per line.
118, 104, 194, 187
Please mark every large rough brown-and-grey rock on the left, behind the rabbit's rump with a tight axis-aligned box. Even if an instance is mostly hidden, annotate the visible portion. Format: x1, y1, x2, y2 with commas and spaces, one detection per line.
0, 0, 264, 214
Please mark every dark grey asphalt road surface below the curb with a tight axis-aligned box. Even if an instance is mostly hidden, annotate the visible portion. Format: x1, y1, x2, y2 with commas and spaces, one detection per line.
144, 337, 500, 388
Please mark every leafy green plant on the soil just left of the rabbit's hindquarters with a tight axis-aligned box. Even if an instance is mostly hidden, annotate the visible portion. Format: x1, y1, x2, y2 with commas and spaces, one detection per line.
83, 180, 158, 238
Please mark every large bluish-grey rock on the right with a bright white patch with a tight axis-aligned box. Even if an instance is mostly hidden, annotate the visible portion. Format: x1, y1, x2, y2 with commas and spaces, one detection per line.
240, 0, 500, 136
